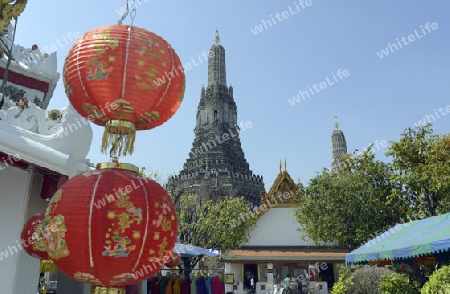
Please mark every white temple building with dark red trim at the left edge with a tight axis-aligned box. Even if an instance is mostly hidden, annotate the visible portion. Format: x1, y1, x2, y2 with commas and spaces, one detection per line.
0, 26, 92, 294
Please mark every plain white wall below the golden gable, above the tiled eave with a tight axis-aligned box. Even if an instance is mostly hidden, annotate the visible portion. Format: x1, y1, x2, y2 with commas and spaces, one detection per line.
244, 207, 314, 246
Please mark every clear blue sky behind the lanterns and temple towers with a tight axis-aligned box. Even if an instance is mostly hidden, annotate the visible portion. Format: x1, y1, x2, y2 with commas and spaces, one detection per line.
16, 0, 450, 189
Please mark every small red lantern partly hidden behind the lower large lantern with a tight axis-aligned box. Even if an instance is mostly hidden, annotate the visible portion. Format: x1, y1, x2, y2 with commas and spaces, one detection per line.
20, 212, 49, 260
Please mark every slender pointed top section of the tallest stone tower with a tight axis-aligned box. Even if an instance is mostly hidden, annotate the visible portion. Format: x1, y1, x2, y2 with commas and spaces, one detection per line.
208, 30, 227, 87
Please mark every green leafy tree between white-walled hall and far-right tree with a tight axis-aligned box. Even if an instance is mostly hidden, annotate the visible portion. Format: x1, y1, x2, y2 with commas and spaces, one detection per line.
296, 146, 402, 249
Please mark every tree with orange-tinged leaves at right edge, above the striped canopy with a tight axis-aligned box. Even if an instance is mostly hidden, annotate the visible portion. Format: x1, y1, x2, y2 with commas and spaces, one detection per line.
386, 124, 450, 219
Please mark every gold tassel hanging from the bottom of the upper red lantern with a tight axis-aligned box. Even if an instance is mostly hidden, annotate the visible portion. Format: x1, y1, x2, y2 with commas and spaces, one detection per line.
101, 120, 136, 156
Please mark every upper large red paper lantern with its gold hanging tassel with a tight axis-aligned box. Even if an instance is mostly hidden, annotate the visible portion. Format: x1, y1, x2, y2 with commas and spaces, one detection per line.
63, 25, 185, 155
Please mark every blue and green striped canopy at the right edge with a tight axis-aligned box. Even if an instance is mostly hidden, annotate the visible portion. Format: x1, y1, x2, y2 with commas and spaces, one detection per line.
345, 213, 450, 263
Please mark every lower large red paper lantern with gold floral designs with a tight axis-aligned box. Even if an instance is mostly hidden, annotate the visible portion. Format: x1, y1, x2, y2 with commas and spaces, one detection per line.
40, 163, 178, 288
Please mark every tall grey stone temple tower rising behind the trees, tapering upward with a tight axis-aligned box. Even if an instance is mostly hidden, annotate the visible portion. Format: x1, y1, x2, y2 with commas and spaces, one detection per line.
167, 31, 265, 205
